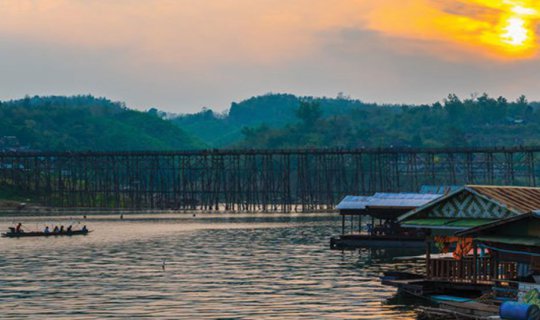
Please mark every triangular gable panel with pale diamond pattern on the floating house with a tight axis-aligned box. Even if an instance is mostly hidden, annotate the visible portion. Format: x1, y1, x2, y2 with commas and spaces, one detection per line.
428, 191, 515, 219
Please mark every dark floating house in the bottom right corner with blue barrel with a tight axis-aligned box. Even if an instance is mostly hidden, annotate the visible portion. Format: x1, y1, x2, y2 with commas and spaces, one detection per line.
412, 211, 540, 319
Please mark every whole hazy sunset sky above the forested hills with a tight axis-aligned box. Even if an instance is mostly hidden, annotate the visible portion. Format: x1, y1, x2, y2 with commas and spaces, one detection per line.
0, 0, 540, 112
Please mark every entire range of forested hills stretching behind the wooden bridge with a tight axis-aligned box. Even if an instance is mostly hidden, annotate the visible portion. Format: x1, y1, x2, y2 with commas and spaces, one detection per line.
0, 94, 540, 151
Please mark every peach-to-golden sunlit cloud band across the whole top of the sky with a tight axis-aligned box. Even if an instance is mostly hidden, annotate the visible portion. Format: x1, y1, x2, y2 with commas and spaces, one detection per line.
0, 0, 540, 71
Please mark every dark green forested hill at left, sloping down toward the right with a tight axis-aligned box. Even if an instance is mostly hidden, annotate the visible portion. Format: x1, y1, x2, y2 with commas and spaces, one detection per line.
0, 96, 205, 151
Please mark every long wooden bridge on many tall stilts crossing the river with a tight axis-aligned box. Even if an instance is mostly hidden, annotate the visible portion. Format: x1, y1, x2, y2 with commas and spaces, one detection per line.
0, 147, 540, 212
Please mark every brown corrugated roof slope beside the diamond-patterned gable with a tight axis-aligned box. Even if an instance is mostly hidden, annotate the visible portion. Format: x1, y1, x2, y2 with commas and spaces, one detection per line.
466, 185, 540, 213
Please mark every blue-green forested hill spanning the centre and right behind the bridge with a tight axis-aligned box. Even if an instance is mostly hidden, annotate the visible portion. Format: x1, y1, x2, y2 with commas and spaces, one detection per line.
172, 94, 540, 148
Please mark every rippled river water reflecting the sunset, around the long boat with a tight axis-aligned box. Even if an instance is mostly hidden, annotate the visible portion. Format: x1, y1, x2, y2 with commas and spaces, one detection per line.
0, 214, 418, 319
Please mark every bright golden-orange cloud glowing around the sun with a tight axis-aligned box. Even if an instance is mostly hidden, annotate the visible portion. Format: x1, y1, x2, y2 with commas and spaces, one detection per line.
367, 0, 540, 60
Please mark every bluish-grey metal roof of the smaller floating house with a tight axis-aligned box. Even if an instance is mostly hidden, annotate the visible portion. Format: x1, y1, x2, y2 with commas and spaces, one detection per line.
336, 193, 442, 210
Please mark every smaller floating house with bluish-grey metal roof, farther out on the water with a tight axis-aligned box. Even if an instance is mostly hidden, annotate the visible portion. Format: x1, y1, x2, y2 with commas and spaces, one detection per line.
330, 187, 450, 249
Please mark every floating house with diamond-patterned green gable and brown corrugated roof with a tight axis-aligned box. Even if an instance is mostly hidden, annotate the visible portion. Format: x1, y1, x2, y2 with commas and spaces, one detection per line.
383, 185, 540, 295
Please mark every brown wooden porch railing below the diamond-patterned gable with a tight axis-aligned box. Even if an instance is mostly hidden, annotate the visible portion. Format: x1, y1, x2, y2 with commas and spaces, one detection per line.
427, 257, 517, 283
